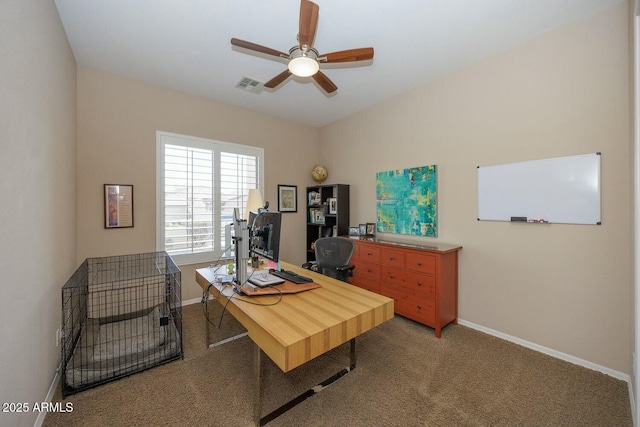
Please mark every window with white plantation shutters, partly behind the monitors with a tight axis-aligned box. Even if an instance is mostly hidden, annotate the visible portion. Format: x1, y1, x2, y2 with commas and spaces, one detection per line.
156, 132, 264, 265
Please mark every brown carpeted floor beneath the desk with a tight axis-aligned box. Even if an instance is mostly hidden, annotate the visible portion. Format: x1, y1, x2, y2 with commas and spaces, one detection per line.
44, 303, 632, 427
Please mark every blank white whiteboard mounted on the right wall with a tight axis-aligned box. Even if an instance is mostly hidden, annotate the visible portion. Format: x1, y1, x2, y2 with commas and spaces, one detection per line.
477, 153, 602, 224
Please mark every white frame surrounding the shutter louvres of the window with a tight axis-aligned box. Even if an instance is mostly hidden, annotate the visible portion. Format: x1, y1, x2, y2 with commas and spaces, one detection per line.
156, 131, 264, 265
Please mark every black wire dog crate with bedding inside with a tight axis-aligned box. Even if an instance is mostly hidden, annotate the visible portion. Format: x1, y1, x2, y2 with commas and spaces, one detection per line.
61, 252, 183, 397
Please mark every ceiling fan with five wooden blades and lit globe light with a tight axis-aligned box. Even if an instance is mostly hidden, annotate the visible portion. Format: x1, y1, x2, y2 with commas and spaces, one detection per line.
231, 0, 373, 93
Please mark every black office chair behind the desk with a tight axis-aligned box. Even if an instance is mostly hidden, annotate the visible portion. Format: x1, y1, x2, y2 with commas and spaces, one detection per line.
315, 237, 355, 283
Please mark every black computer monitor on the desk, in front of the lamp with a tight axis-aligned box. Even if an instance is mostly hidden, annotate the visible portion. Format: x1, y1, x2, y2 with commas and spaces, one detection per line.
249, 211, 282, 262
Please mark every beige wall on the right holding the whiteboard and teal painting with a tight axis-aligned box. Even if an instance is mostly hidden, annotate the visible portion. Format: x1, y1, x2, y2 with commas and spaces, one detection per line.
321, 3, 633, 374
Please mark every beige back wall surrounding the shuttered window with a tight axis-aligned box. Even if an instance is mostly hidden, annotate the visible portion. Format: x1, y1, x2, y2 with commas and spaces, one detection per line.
77, 66, 320, 300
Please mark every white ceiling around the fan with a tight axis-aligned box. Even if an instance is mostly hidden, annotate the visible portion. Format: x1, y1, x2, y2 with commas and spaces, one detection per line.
55, 0, 624, 127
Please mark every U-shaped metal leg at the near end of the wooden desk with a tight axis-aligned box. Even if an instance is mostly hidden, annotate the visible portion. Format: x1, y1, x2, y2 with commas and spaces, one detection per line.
254, 338, 356, 427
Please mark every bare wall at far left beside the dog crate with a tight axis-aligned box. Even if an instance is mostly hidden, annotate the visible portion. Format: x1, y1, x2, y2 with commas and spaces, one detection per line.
0, 0, 76, 426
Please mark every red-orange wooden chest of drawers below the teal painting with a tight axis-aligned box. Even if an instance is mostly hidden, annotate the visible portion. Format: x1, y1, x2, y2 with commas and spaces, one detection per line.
350, 239, 462, 338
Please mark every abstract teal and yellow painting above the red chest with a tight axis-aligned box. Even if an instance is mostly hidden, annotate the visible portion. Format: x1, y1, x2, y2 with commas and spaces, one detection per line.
376, 165, 438, 237
